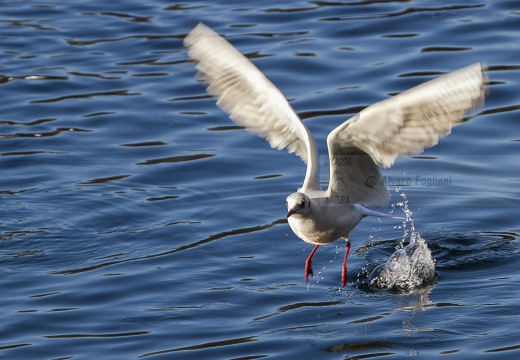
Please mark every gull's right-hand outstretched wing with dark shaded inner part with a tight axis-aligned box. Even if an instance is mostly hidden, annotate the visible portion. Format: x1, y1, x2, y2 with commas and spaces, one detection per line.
327, 63, 486, 205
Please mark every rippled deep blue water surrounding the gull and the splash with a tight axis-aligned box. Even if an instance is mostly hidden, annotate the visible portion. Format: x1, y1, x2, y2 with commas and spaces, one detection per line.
0, 0, 520, 360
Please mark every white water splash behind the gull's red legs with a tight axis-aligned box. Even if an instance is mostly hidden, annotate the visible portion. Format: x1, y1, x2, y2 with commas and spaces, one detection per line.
369, 193, 435, 291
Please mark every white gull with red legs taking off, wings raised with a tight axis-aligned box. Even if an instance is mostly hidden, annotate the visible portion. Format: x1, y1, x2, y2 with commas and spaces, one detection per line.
184, 23, 486, 287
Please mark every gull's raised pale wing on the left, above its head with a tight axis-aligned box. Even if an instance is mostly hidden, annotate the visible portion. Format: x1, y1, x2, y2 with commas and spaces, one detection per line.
184, 24, 319, 190
